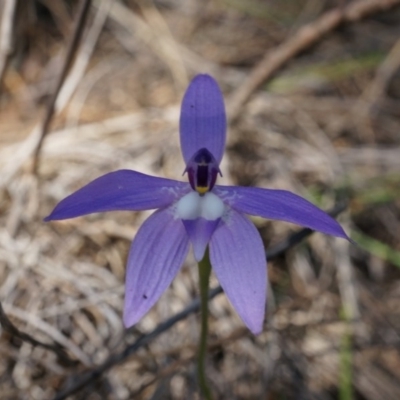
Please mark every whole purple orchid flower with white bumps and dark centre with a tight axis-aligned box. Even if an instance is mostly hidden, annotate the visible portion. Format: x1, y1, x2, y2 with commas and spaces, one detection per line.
45, 75, 347, 334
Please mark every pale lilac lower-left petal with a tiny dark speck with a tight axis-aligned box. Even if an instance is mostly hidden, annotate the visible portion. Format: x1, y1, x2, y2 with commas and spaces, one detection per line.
124, 208, 189, 328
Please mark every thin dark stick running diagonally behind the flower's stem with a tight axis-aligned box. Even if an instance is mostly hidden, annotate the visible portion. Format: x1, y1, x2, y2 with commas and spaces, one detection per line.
54, 203, 347, 400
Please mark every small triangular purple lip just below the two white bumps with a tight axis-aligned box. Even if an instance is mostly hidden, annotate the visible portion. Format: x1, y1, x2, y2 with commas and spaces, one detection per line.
182, 218, 220, 261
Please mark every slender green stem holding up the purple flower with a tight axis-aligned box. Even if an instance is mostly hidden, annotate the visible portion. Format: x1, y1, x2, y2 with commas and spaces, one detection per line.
197, 249, 212, 400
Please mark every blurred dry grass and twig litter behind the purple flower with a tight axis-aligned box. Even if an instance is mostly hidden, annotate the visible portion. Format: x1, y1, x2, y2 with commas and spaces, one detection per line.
0, 0, 400, 400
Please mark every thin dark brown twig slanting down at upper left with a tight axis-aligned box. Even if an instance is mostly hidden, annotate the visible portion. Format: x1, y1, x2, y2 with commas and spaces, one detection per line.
32, 0, 92, 173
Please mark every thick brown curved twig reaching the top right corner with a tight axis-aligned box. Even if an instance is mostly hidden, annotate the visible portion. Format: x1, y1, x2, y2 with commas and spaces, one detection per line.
228, 0, 400, 121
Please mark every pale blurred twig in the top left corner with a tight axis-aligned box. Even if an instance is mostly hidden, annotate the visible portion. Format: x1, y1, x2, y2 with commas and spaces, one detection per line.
0, 0, 17, 85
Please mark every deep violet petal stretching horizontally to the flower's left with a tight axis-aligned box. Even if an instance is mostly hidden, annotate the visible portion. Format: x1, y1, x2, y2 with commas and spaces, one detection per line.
44, 170, 190, 221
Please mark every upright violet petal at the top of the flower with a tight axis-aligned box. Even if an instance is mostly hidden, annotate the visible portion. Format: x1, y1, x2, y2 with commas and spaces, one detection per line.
180, 75, 226, 164
